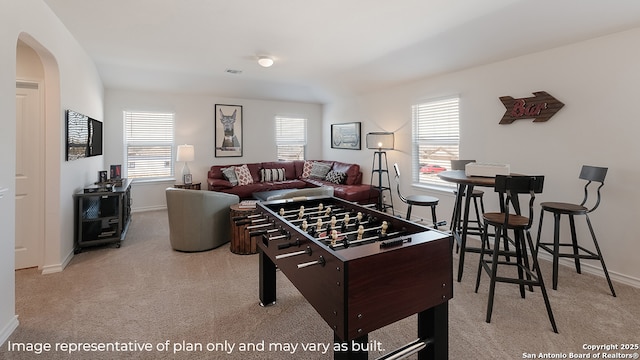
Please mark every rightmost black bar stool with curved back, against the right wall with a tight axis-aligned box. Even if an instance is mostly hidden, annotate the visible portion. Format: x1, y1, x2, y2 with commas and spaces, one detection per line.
536, 165, 616, 297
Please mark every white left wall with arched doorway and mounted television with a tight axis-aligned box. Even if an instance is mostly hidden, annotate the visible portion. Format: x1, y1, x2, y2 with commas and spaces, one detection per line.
0, 0, 103, 343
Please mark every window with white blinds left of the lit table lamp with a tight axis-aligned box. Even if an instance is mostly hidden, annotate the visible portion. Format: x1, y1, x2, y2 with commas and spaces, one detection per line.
124, 111, 175, 179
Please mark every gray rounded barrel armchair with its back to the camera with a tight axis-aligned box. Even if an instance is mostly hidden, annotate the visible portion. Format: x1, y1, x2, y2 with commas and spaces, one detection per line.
165, 188, 240, 252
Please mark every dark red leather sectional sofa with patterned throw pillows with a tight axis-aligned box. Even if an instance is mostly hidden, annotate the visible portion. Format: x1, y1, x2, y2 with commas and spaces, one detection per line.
207, 160, 378, 204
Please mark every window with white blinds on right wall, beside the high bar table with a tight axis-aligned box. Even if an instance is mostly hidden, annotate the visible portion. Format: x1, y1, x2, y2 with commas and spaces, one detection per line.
412, 96, 460, 187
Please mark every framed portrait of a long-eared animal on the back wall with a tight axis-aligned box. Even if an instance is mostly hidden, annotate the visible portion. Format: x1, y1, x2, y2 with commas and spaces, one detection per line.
214, 104, 243, 157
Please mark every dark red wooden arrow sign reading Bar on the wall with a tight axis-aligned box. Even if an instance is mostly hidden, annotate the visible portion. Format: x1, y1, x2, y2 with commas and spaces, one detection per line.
500, 91, 564, 124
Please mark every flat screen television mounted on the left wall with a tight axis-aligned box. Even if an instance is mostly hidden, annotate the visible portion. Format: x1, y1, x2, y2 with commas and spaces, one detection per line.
66, 110, 103, 161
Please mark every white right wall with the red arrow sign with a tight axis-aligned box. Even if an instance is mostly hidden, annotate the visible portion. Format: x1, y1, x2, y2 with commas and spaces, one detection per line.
323, 29, 640, 286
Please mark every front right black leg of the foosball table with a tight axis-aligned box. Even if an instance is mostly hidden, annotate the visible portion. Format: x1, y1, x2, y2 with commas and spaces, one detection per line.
418, 301, 449, 360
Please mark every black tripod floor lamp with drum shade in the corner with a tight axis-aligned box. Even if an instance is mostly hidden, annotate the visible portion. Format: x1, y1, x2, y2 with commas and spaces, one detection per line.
367, 132, 394, 214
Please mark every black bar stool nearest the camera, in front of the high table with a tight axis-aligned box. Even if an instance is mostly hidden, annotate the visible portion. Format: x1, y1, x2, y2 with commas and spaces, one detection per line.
475, 175, 558, 333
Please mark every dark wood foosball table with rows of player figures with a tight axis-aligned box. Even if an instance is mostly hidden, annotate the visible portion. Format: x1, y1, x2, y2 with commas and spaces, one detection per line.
235, 197, 453, 360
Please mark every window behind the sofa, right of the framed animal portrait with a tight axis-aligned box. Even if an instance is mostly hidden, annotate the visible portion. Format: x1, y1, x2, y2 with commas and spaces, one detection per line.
275, 115, 307, 160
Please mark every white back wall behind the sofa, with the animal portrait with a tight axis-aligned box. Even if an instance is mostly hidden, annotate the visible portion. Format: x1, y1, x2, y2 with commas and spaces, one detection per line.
105, 90, 322, 211
